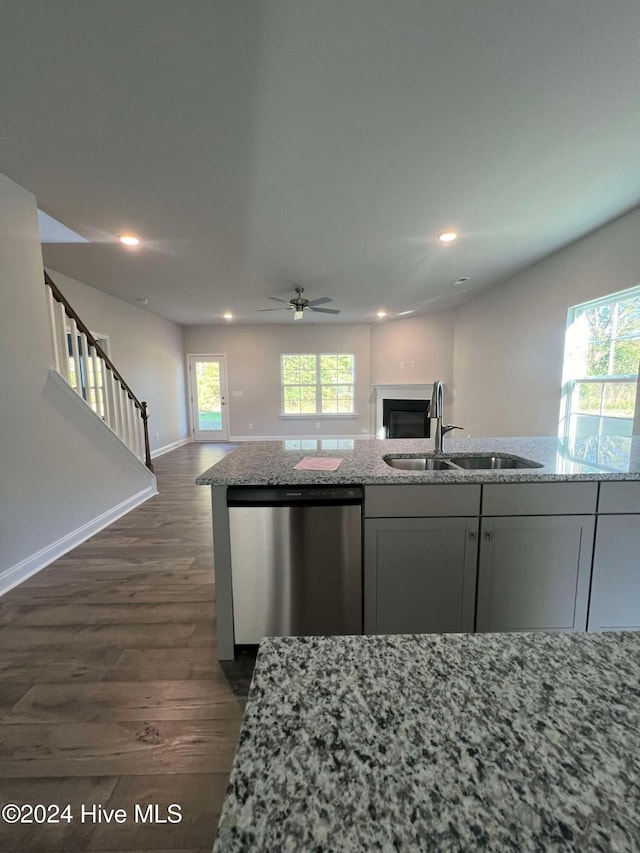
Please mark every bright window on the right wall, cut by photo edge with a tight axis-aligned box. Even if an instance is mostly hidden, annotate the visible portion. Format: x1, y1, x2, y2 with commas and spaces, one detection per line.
560, 287, 640, 439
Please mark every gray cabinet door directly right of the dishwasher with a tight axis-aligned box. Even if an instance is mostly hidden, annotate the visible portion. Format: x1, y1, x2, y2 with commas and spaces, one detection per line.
364, 518, 478, 634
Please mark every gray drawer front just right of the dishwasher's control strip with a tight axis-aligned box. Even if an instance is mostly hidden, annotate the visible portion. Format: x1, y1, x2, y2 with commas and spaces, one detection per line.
364, 483, 480, 518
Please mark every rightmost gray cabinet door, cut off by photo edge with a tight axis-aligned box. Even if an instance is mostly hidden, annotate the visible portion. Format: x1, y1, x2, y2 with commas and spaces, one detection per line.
589, 515, 640, 631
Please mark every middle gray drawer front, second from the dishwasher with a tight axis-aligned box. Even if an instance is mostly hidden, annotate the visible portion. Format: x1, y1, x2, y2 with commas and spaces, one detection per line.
482, 483, 598, 515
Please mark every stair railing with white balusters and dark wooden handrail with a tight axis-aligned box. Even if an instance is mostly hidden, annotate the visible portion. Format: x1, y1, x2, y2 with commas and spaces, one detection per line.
44, 270, 153, 471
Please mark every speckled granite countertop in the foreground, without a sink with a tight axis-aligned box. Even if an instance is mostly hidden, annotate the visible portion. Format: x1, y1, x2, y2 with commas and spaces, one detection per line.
214, 633, 640, 853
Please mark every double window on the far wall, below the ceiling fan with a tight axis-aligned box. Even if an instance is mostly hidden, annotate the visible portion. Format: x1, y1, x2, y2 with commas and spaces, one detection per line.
281, 353, 356, 415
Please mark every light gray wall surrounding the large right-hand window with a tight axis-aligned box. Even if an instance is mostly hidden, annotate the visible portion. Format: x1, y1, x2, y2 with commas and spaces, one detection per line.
453, 204, 640, 436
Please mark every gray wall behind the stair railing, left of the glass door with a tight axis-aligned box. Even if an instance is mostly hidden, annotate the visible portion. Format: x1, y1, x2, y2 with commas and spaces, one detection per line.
49, 270, 188, 451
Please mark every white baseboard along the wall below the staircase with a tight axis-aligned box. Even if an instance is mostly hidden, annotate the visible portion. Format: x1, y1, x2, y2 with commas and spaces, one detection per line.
0, 482, 158, 595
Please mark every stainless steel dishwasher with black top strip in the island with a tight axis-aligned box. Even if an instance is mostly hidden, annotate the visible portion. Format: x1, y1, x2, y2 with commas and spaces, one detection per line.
227, 486, 362, 644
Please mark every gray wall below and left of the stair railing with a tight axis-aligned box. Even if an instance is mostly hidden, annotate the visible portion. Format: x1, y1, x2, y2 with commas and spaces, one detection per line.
0, 175, 155, 585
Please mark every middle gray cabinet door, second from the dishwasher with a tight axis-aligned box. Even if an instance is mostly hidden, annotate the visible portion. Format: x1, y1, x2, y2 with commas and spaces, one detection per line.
476, 515, 594, 631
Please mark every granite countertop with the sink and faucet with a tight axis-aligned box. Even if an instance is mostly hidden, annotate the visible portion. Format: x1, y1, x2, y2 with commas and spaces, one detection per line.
196, 436, 640, 486
